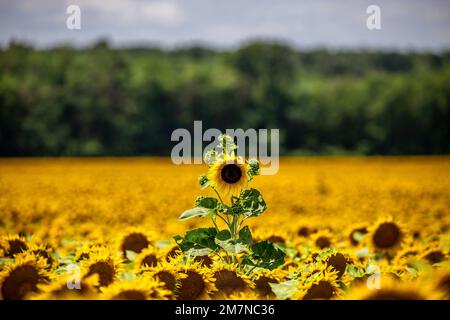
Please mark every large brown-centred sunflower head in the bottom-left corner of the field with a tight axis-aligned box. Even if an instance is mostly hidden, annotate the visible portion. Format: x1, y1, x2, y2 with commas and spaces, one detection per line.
0, 253, 49, 300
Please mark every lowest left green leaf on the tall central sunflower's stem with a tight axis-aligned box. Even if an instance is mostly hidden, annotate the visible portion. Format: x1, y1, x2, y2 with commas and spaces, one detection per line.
174, 228, 219, 256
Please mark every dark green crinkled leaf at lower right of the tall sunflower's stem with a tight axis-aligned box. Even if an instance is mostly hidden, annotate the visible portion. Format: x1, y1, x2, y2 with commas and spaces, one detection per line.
243, 241, 286, 270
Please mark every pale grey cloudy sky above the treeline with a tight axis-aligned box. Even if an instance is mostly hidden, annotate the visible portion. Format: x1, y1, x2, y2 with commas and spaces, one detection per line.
0, 0, 450, 50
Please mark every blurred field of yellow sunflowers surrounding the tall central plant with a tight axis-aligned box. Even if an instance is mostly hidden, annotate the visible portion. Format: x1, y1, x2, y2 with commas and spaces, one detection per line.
0, 157, 450, 299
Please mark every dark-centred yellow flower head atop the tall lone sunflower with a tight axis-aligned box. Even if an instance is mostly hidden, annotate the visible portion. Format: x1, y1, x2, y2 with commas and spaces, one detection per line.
208, 154, 248, 195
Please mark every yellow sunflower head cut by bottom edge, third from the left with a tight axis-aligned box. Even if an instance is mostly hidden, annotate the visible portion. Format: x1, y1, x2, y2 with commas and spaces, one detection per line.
101, 276, 171, 300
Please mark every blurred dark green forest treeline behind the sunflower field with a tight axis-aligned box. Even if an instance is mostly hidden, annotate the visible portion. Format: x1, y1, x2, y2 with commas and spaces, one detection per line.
0, 40, 450, 156
